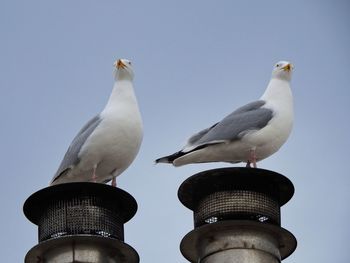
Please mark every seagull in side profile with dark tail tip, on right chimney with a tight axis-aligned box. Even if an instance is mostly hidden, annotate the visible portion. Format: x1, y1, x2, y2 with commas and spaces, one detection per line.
155, 61, 294, 168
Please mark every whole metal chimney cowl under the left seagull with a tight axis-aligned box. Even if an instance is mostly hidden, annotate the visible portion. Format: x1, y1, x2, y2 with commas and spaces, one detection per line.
23, 182, 139, 263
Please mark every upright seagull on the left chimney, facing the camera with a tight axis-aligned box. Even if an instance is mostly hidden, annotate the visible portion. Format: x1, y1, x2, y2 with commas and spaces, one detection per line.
50, 59, 143, 186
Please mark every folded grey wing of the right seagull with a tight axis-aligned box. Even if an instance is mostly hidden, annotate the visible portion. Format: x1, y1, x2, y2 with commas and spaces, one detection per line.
189, 100, 273, 151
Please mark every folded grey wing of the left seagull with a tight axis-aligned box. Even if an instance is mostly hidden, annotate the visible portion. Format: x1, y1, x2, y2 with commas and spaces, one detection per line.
51, 115, 101, 185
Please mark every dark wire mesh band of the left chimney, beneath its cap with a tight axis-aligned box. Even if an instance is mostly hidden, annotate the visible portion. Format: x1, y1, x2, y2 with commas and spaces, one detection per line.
38, 195, 124, 242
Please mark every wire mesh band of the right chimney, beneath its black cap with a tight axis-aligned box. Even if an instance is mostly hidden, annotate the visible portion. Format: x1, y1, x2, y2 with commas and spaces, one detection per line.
194, 190, 281, 227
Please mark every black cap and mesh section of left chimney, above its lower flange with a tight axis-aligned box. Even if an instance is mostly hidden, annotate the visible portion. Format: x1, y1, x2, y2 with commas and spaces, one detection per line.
23, 182, 137, 243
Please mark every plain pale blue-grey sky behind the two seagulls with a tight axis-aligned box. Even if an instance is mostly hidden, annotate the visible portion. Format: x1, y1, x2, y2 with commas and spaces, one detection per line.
0, 0, 350, 263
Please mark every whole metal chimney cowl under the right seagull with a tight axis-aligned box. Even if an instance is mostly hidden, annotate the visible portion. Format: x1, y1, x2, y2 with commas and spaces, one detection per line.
178, 167, 297, 263
